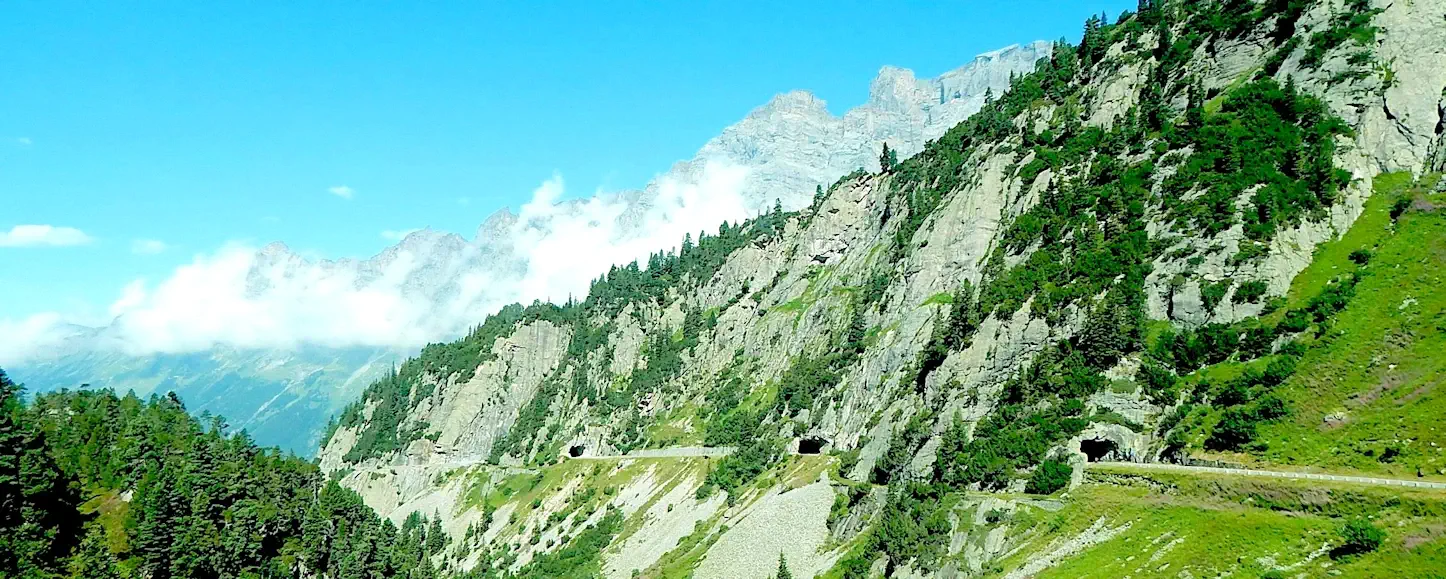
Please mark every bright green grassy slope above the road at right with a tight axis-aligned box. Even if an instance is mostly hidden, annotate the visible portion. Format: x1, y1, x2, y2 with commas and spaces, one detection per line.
1174, 175, 1446, 479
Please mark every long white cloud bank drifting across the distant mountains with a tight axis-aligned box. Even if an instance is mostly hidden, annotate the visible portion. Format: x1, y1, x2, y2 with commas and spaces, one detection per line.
0, 164, 749, 365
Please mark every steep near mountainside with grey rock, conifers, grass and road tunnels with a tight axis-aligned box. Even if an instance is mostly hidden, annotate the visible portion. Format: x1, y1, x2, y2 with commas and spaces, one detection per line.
320, 0, 1446, 578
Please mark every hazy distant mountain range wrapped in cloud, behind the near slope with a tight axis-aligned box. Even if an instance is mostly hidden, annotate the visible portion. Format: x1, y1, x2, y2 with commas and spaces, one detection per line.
2, 42, 1050, 455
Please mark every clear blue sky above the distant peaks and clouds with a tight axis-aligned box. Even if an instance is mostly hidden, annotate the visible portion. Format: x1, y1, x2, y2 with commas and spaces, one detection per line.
0, 0, 1135, 320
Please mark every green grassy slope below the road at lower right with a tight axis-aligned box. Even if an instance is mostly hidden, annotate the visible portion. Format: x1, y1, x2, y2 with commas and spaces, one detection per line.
995, 472, 1446, 579
